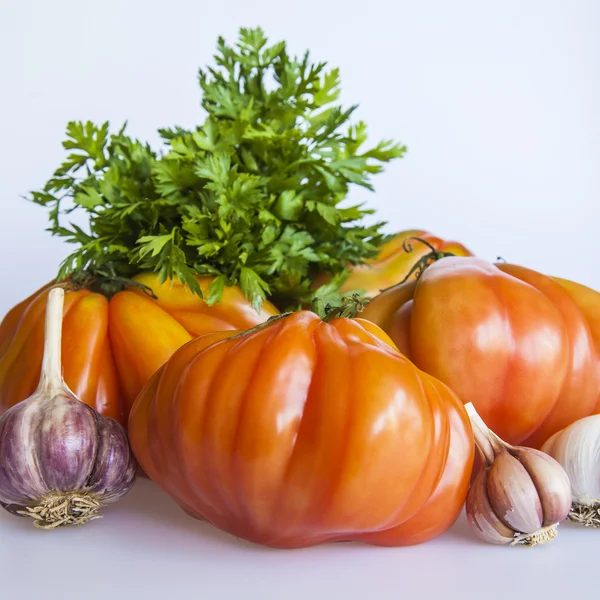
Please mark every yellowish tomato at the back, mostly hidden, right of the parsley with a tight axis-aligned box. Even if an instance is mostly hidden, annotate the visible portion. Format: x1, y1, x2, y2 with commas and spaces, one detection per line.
330, 229, 471, 298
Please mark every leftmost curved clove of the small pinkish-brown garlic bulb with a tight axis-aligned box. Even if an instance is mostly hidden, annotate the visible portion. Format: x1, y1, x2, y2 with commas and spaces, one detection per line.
466, 469, 514, 544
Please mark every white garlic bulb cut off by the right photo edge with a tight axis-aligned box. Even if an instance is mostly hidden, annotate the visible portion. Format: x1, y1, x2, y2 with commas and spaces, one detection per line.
542, 415, 600, 527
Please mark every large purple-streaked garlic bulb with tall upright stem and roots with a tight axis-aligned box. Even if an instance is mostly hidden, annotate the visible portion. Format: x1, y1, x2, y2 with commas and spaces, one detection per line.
0, 287, 138, 529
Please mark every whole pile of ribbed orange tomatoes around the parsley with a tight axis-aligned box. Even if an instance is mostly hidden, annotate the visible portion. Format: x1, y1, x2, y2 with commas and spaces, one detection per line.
0, 231, 600, 548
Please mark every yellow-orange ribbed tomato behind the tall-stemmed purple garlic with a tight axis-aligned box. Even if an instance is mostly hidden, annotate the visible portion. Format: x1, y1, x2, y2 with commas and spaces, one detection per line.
0, 274, 278, 423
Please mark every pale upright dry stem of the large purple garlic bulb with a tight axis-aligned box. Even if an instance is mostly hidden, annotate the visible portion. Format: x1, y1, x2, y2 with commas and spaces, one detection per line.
38, 287, 65, 393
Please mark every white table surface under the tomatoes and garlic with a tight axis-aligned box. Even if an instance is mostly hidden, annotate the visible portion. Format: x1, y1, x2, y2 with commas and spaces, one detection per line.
0, 480, 600, 600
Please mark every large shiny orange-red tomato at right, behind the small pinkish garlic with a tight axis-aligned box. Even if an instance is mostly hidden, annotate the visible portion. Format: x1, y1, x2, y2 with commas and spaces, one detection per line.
361, 257, 600, 448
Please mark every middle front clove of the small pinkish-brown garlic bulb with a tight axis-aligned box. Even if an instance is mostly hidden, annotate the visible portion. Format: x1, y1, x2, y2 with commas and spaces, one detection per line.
487, 448, 544, 533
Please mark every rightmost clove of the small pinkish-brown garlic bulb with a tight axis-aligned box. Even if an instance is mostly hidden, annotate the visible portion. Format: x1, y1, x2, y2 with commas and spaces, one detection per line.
512, 448, 571, 526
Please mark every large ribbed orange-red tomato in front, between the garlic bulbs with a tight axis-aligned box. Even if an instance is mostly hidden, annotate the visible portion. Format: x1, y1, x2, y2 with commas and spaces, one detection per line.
129, 311, 473, 548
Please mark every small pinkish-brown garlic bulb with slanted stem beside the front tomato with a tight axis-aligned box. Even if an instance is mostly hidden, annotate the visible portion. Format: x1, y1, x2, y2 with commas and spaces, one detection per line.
465, 403, 571, 546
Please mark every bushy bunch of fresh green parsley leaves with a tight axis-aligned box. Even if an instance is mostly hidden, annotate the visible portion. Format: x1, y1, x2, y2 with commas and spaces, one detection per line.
32, 29, 406, 307
